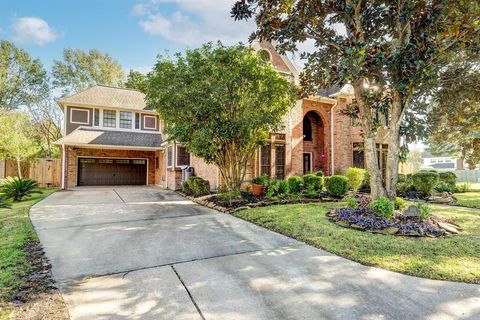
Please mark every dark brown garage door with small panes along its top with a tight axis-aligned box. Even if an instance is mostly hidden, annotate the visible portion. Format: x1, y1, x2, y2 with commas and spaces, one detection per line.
78, 158, 147, 186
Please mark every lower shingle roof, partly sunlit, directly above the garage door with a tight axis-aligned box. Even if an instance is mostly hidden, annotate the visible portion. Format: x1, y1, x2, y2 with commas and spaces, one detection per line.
55, 127, 163, 148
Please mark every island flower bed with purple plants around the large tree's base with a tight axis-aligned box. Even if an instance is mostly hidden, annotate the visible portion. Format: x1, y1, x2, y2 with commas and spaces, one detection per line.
326, 197, 460, 237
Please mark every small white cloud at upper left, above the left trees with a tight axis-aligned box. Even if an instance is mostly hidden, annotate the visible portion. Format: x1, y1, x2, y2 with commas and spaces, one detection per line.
11, 17, 60, 46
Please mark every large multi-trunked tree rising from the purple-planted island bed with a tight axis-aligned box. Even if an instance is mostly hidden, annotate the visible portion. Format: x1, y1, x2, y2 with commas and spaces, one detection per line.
231, 0, 480, 199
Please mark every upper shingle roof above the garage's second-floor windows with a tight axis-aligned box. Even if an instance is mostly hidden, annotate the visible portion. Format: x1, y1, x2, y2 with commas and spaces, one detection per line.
57, 85, 146, 110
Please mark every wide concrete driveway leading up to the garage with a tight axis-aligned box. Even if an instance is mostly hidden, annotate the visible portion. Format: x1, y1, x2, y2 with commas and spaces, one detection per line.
30, 187, 480, 320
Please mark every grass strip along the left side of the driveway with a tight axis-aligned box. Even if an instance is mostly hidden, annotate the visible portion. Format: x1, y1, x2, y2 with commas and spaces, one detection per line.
0, 189, 57, 302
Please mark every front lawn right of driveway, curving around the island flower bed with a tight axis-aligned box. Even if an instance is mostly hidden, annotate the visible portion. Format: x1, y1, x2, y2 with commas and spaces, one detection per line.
234, 203, 480, 284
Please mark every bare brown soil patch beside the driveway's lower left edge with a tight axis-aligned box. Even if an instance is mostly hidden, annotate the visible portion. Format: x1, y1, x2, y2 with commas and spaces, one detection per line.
4, 242, 69, 320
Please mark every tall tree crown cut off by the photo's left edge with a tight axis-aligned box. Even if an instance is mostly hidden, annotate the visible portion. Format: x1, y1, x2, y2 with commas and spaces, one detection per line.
0, 40, 49, 111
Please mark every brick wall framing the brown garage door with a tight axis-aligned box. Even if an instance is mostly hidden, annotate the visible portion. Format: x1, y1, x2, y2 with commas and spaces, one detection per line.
66, 147, 155, 188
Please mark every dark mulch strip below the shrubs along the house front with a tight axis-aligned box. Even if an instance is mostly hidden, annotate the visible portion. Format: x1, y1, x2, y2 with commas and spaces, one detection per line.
178, 192, 339, 213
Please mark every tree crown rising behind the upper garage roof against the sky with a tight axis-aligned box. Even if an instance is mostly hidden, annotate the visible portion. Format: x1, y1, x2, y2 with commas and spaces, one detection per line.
52, 49, 125, 95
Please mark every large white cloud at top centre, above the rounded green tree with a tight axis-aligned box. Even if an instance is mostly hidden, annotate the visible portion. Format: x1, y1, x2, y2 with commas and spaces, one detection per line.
132, 0, 255, 46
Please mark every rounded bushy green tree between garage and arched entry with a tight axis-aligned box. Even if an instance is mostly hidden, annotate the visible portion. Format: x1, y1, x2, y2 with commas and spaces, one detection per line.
146, 42, 295, 191
